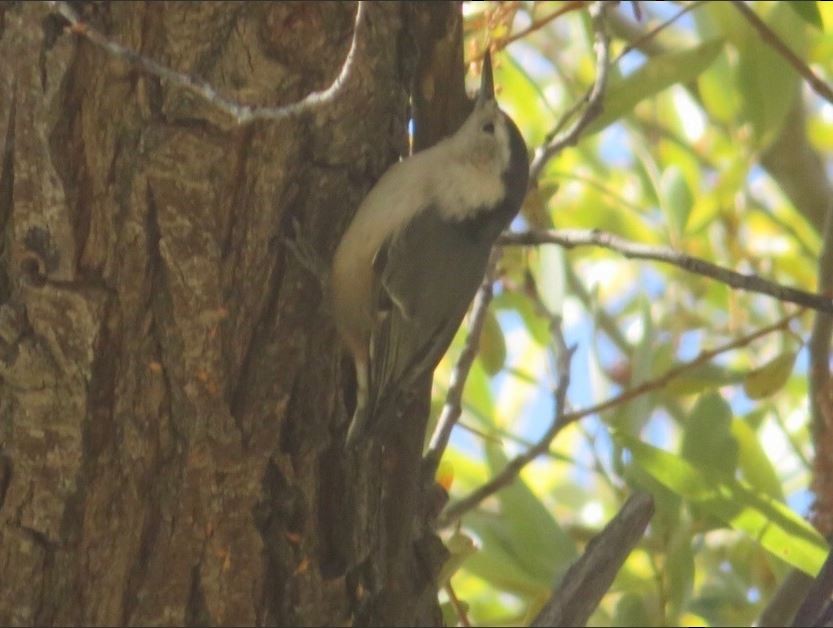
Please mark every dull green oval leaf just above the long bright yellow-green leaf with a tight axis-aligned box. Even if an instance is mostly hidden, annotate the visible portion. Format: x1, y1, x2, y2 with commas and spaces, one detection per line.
682, 392, 738, 476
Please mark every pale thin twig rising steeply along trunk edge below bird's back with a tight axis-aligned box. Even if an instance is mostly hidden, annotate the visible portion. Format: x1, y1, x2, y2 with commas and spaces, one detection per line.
424, 252, 496, 478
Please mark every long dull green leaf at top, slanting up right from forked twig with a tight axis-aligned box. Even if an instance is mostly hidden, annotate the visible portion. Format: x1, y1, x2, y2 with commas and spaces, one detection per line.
586, 39, 723, 134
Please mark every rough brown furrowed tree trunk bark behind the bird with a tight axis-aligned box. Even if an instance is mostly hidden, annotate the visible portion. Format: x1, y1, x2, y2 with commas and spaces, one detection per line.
0, 2, 463, 625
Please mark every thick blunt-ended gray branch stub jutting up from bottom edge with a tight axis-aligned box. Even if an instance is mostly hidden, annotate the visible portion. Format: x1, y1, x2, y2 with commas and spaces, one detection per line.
531, 493, 654, 626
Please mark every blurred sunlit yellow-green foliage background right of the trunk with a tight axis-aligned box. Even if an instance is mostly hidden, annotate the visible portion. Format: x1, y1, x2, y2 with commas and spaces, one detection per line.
434, 2, 833, 626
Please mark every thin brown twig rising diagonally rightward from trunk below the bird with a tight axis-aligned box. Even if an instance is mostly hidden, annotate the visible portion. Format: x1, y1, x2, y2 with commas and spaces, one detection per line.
437, 310, 802, 527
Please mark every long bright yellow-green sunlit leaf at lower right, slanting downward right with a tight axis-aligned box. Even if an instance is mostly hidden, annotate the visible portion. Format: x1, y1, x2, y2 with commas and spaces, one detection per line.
614, 430, 829, 576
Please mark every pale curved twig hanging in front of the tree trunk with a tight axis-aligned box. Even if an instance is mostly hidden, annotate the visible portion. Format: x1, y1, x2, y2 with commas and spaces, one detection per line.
50, 0, 366, 124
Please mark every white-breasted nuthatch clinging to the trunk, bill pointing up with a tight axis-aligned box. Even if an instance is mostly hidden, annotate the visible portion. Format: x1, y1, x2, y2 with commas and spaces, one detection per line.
330, 53, 529, 445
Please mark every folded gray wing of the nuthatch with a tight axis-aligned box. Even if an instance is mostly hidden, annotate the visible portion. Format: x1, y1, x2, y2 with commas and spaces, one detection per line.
360, 208, 491, 434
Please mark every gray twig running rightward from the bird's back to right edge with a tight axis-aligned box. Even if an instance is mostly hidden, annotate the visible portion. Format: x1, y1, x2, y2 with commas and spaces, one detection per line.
499, 229, 833, 313
